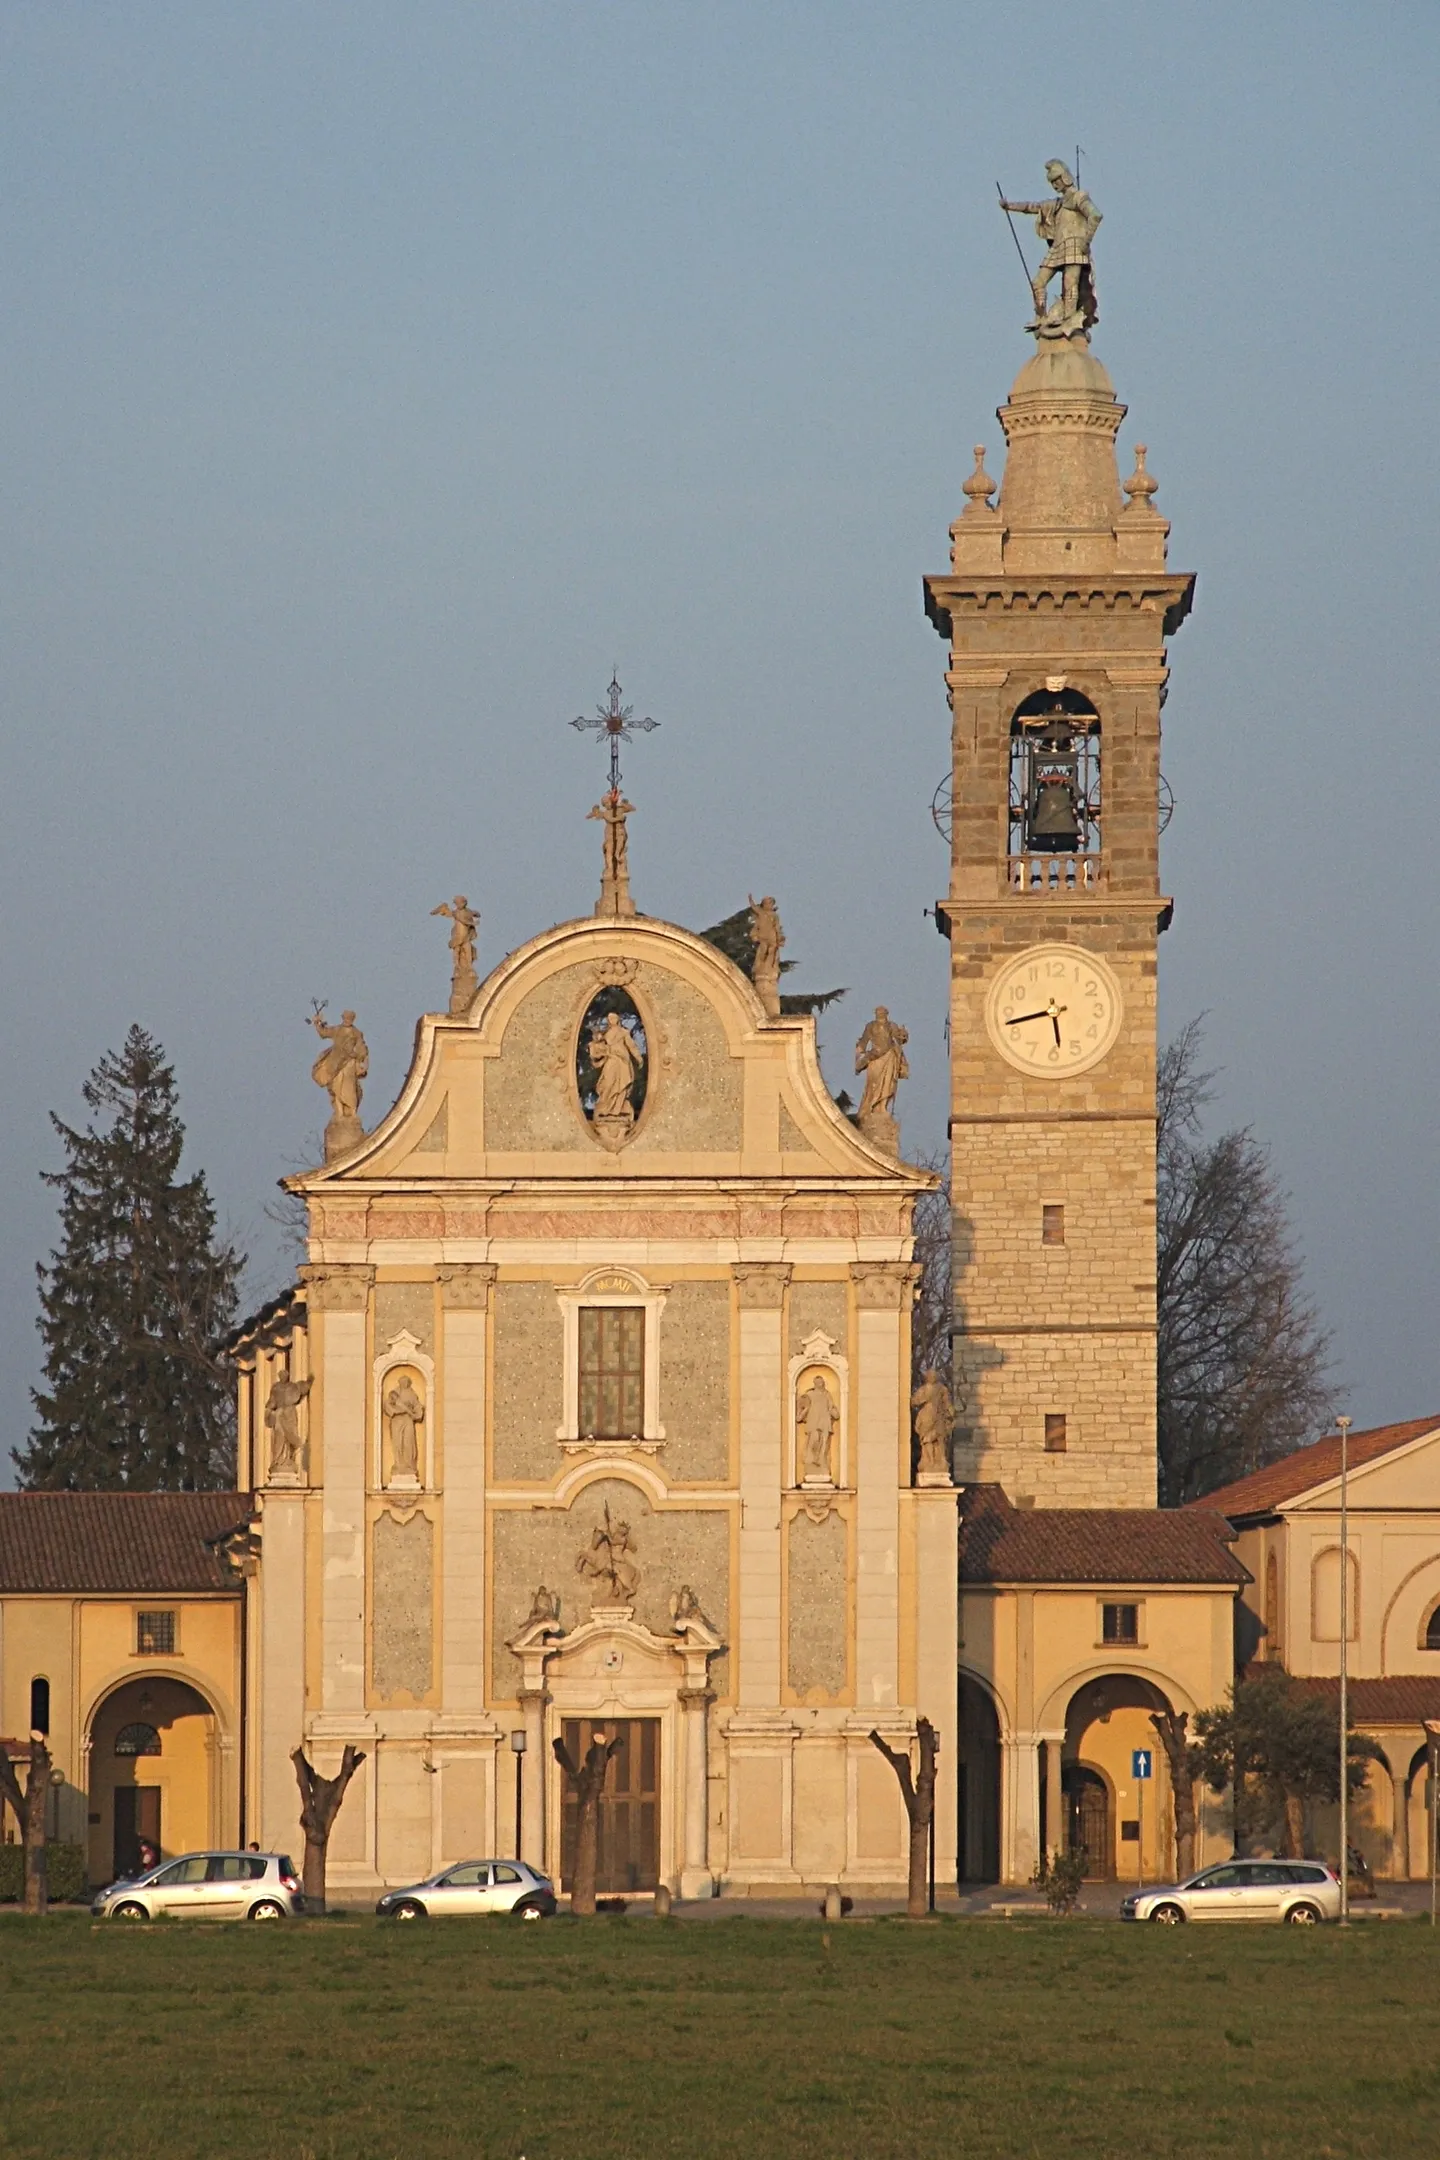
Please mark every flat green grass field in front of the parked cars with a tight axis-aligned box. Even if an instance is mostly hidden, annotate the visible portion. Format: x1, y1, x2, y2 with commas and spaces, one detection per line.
0, 1914, 1440, 2160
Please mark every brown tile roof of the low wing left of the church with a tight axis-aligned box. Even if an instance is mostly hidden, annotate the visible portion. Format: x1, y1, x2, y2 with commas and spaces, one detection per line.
0, 1493, 250, 1596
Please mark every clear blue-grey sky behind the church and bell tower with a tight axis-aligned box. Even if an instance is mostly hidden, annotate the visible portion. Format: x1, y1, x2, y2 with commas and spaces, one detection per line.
0, 0, 1440, 1445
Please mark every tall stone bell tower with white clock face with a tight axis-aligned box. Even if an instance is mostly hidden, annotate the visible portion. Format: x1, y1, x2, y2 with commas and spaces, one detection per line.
924, 232, 1194, 1508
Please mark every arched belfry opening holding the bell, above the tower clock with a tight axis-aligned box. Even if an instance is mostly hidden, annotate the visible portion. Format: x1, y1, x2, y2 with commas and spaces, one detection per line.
1008, 689, 1101, 892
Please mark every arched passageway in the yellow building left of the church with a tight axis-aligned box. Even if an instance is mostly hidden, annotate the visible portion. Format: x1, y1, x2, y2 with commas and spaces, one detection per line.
89, 1674, 218, 1881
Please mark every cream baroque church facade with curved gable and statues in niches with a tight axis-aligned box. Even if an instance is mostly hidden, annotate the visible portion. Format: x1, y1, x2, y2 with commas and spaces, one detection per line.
237, 885, 956, 1896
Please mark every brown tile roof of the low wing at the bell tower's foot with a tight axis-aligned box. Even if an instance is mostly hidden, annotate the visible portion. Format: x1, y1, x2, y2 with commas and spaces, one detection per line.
961, 1486, 1250, 1585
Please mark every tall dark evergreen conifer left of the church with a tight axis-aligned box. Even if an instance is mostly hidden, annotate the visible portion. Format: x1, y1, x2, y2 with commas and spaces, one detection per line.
13, 1026, 244, 1490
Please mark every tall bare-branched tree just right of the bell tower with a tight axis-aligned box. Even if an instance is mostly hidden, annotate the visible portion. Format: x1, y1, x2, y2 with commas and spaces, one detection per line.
1155, 1020, 1334, 1508
